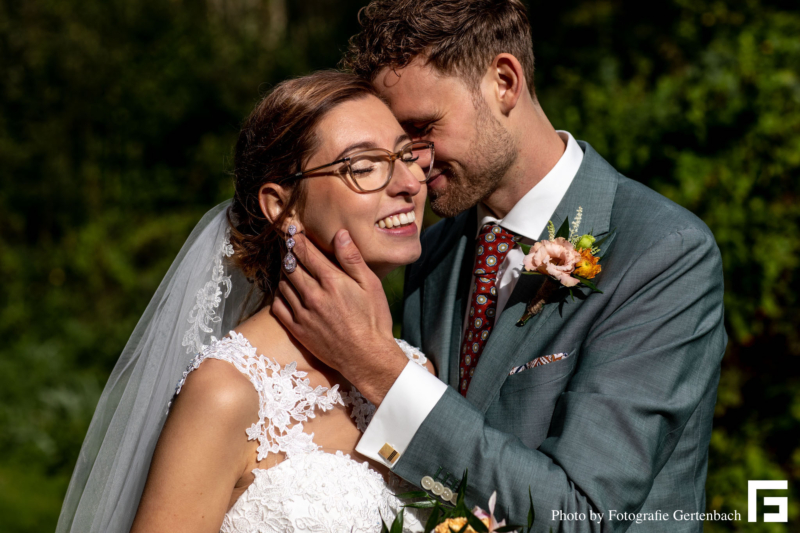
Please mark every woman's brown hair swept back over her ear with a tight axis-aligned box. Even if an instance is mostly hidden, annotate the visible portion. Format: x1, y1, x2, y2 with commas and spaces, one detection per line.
228, 71, 377, 306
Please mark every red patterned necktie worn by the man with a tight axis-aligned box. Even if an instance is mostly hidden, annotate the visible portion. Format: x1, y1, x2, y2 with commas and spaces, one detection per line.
458, 224, 515, 396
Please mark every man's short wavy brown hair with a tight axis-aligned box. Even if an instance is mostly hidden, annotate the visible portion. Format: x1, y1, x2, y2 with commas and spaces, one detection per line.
342, 0, 534, 95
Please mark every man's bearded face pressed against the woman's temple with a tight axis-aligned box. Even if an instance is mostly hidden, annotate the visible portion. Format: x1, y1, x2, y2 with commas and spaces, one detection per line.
374, 58, 517, 217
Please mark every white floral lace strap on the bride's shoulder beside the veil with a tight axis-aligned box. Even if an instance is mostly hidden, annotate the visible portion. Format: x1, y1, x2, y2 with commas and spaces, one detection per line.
175, 331, 344, 461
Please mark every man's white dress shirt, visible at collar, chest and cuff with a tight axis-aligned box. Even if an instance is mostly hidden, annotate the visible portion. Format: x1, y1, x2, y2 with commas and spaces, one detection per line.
356, 131, 583, 467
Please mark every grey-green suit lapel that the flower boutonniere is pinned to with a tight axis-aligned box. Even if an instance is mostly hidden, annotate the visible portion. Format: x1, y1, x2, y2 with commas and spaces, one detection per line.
462, 141, 618, 412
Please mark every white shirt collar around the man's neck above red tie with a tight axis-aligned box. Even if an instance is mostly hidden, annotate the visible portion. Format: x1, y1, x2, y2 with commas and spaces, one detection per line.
476, 131, 583, 241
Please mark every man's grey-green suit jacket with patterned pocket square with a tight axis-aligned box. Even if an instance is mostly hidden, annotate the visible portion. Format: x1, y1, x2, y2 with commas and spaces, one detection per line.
404, 142, 727, 532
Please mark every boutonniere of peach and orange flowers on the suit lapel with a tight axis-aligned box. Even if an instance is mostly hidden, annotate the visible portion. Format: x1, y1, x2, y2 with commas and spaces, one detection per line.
517, 207, 616, 326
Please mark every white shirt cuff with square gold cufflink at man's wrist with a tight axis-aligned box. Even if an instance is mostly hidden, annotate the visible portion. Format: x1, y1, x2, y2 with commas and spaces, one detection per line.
356, 361, 447, 468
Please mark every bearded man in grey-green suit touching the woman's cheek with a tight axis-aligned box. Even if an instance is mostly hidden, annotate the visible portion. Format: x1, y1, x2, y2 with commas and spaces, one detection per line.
274, 0, 727, 531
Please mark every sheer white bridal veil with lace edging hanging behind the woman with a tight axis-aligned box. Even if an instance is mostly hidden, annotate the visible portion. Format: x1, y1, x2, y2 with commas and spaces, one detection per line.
56, 201, 259, 533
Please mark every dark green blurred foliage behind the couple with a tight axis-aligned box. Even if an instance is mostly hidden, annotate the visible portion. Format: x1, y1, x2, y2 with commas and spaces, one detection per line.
0, 0, 800, 532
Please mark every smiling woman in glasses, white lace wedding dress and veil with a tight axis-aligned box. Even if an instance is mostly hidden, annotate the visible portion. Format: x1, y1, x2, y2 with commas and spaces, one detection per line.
57, 72, 433, 533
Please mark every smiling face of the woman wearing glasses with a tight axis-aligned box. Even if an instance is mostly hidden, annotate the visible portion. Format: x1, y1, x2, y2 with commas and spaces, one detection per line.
296, 96, 427, 277
